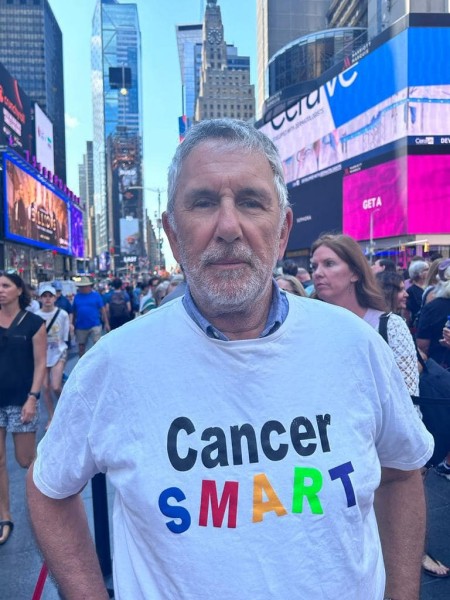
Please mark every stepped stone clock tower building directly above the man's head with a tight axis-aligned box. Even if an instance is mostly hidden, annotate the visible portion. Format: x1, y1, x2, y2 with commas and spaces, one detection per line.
195, 0, 255, 121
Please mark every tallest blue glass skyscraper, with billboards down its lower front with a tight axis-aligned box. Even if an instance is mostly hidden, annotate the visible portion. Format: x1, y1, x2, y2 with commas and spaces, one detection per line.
91, 0, 145, 272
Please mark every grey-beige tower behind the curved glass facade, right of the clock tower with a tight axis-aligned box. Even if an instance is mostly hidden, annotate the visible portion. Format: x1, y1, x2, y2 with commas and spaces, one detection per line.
256, 0, 330, 116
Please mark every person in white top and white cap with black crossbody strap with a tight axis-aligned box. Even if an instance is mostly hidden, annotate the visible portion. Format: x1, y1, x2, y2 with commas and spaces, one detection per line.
36, 283, 70, 428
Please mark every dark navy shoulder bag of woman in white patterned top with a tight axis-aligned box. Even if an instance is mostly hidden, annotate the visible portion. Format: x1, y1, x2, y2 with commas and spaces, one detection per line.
378, 313, 450, 467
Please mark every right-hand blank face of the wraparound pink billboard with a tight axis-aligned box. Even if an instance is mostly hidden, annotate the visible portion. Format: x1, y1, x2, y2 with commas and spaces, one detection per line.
408, 155, 450, 235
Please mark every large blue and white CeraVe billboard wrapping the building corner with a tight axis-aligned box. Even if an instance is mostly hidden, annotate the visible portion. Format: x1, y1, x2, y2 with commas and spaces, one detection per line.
261, 28, 450, 184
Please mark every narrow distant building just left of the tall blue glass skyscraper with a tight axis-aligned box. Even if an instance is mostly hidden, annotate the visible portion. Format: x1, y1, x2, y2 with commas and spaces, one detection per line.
78, 142, 96, 271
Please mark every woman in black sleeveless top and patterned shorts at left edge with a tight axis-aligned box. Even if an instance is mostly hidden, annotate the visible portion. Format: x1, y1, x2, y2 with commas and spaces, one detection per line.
0, 273, 47, 545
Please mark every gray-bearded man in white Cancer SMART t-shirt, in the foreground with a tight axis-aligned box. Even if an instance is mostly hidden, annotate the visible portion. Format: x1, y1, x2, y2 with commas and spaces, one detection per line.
28, 119, 433, 600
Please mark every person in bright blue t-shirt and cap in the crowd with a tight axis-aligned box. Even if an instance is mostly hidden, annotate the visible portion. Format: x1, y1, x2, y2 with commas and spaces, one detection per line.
73, 276, 109, 358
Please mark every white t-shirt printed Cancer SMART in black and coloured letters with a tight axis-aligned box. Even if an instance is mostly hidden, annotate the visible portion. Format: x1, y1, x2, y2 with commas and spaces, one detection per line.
34, 296, 433, 600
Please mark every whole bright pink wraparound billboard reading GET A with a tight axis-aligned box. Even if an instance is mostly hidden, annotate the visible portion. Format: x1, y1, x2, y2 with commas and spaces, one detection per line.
343, 154, 450, 240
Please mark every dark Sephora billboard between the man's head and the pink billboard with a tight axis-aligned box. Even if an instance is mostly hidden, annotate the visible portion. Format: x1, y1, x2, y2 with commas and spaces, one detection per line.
287, 171, 342, 252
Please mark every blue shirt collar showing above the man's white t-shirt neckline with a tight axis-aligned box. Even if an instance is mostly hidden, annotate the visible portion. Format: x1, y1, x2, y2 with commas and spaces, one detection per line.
183, 280, 289, 342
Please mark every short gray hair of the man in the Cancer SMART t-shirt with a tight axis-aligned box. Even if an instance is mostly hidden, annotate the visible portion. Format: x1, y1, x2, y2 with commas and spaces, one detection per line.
167, 119, 290, 227
